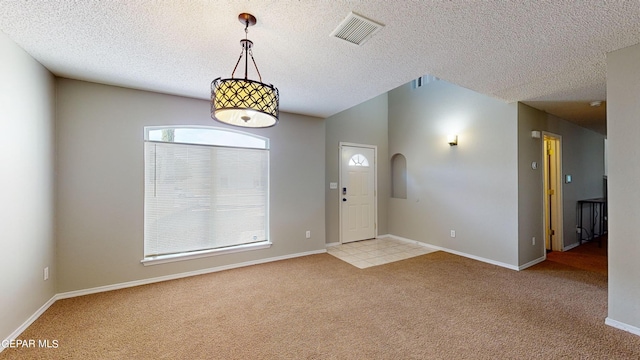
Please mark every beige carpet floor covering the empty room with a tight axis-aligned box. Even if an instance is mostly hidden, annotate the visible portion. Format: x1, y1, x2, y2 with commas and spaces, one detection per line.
0, 243, 640, 359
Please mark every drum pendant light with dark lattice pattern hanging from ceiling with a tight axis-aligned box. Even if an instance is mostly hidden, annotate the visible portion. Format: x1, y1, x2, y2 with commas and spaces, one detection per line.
211, 13, 279, 128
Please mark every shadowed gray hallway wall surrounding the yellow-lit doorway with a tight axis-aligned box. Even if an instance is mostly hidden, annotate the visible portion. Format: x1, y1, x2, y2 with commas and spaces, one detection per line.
518, 104, 604, 265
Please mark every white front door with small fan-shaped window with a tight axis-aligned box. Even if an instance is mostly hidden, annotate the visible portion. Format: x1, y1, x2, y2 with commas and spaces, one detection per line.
339, 145, 376, 243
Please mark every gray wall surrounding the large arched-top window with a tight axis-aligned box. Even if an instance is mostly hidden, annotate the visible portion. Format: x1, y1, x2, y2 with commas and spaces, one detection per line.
54, 79, 325, 292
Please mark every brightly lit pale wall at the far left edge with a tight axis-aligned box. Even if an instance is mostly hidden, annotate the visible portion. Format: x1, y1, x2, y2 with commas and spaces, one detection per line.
0, 32, 57, 340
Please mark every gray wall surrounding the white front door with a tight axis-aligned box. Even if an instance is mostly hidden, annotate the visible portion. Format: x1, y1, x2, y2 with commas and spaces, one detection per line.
324, 94, 391, 243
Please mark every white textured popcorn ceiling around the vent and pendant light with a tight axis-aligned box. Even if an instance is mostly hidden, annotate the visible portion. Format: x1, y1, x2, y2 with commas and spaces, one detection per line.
0, 0, 640, 131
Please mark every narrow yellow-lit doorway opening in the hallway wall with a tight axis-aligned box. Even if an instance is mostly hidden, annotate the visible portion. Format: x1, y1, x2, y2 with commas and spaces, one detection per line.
542, 133, 564, 252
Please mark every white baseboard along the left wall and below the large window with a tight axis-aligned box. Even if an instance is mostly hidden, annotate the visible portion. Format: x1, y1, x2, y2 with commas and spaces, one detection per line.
0, 249, 327, 352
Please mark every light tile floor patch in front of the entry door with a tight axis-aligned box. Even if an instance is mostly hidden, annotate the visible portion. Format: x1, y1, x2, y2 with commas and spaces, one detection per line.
327, 238, 437, 269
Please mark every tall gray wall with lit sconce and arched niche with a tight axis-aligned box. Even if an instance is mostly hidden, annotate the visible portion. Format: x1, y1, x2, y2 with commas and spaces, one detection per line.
388, 81, 518, 266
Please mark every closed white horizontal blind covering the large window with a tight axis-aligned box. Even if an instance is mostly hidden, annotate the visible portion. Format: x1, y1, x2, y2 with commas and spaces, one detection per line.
144, 129, 269, 258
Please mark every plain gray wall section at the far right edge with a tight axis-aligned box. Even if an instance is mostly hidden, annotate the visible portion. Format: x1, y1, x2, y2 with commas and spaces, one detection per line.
607, 45, 640, 334
